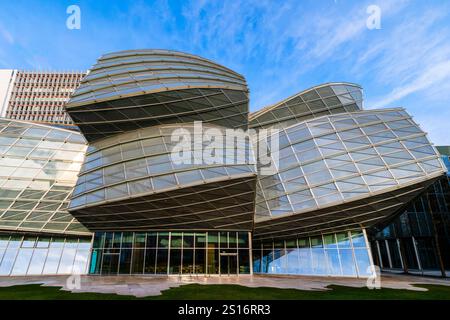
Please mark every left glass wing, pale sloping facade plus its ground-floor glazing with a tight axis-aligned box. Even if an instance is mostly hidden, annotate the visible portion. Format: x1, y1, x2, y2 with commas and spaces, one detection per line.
0, 118, 92, 276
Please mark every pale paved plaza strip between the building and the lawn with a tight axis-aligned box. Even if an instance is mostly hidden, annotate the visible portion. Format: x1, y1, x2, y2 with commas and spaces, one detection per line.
0, 274, 450, 297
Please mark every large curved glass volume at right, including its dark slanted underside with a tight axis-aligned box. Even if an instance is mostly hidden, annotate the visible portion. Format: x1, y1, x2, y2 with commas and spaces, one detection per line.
256, 109, 445, 236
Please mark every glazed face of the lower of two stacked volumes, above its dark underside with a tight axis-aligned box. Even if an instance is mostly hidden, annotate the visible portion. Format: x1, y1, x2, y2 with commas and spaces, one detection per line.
70, 124, 256, 210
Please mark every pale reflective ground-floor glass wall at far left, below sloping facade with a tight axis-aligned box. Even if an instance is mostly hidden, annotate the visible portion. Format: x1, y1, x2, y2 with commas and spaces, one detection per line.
0, 234, 91, 276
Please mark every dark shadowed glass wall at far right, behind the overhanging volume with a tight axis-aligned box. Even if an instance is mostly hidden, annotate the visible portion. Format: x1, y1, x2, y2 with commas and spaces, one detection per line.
371, 177, 450, 277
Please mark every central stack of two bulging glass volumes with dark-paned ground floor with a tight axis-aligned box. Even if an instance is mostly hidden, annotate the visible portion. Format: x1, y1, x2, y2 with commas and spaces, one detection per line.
66, 50, 256, 274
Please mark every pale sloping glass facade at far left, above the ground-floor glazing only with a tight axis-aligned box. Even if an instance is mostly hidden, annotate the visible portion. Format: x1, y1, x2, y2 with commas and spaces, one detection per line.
0, 119, 91, 235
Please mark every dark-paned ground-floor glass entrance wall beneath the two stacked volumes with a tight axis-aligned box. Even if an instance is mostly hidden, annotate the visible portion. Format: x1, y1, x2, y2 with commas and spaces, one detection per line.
90, 231, 251, 275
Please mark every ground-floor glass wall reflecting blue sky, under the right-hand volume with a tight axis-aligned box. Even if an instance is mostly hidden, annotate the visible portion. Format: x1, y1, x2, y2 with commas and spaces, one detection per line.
253, 231, 370, 277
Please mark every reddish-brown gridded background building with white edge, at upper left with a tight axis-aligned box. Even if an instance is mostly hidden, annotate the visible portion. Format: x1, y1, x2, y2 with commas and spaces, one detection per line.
0, 69, 85, 126
